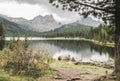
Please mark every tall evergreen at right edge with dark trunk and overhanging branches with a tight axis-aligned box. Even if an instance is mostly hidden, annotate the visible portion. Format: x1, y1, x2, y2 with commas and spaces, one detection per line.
49, 0, 120, 74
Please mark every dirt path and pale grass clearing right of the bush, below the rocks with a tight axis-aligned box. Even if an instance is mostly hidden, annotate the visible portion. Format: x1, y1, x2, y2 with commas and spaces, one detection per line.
39, 62, 114, 81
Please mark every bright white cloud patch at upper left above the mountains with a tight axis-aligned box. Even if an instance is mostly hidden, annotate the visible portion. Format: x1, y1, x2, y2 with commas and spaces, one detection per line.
0, 2, 49, 19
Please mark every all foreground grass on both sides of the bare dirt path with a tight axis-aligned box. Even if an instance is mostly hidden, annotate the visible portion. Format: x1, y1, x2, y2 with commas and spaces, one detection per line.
0, 61, 112, 81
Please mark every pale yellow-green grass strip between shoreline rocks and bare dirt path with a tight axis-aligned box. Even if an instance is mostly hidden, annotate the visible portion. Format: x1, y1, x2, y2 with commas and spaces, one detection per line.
50, 61, 112, 76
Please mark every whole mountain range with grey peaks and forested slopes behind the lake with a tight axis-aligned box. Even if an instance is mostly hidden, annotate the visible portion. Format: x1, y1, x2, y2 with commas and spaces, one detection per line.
0, 14, 101, 37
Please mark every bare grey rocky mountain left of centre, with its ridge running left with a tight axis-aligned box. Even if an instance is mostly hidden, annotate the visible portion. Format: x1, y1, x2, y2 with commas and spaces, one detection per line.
0, 15, 59, 32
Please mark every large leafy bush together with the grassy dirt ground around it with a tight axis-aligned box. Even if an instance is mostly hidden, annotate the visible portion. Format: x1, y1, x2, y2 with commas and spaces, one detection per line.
0, 38, 116, 81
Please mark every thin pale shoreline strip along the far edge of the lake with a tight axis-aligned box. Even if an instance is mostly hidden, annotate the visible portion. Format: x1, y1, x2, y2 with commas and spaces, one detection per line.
5, 37, 114, 47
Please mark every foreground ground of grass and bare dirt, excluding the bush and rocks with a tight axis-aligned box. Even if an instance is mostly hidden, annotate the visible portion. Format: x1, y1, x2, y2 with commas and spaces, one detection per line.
0, 60, 112, 81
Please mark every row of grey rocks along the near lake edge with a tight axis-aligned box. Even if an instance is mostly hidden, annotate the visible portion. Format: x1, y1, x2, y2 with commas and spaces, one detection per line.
58, 55, 114, 69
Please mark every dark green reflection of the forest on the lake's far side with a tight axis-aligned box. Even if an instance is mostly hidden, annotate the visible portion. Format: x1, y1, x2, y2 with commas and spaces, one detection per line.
44, 40, 114, 57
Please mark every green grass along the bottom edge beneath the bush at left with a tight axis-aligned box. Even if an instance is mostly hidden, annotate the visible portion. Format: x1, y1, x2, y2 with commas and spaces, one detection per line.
0, 69, 55, 81
